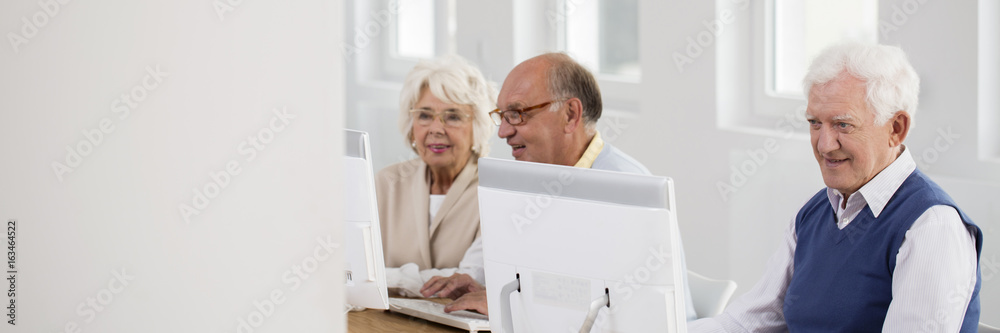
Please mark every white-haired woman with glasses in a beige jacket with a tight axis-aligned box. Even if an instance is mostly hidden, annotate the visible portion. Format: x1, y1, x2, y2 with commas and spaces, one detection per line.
375, 56, 496, 296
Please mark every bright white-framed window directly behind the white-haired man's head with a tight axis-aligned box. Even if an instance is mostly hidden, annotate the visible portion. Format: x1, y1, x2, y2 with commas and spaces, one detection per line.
716, 0, 878, 132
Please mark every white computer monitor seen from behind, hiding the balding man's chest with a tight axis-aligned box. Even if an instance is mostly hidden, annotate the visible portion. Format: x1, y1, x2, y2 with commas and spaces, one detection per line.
479, 158, 687, 333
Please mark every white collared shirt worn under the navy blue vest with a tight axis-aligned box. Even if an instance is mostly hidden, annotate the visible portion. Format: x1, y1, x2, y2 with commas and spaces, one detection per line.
688, 147, 977, 332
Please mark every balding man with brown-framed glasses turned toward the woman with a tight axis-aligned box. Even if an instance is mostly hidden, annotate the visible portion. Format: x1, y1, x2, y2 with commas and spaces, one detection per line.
421, 53, 696, 320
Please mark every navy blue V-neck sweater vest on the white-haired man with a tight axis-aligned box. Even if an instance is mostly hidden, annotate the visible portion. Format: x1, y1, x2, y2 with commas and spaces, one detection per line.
783, 170, 983, 332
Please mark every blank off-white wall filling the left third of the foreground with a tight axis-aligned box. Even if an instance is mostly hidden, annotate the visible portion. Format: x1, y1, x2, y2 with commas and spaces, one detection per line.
0, 0, 345, 332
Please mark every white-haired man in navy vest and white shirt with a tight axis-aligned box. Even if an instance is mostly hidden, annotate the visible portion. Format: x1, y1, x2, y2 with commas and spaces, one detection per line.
689, 43, 983, 332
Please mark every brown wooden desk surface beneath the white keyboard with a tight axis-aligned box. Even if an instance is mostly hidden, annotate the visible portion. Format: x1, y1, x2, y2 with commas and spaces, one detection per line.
347, 299, 484, 333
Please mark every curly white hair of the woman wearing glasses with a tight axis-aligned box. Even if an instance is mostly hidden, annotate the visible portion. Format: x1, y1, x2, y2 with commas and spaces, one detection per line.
399, 55, 497, 157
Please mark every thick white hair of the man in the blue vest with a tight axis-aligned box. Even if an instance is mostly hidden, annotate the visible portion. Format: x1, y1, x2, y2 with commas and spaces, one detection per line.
802, 42, 920, 126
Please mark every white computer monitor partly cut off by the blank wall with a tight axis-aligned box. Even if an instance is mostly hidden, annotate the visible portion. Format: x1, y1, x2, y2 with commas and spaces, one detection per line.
344, 130, 389, 309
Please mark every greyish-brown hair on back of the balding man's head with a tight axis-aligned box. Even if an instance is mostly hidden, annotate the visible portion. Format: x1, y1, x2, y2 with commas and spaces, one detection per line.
544, 53, 603, 129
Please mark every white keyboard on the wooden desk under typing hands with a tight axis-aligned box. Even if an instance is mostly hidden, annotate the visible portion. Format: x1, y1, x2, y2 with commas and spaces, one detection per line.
389, 297, 490, 333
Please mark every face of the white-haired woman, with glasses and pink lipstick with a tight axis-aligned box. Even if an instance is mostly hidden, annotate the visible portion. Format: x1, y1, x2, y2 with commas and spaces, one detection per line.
410, 89, 473, 170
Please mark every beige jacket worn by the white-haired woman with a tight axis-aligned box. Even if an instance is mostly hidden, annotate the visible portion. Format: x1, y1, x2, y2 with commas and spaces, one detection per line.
375, 157, 479, 270
